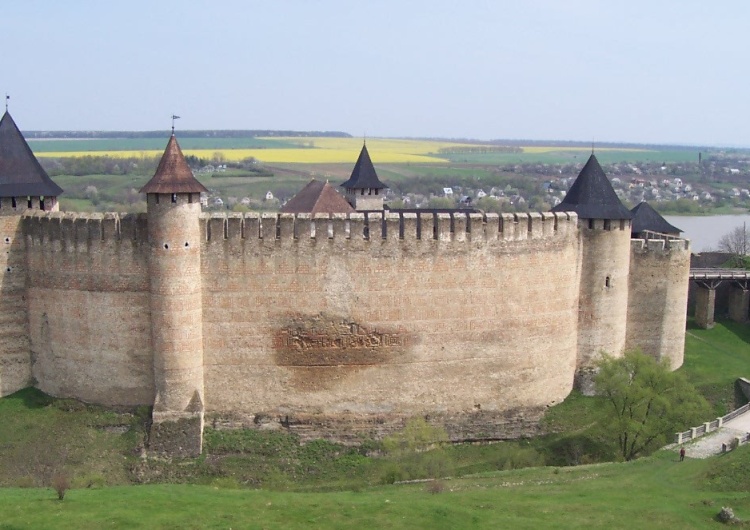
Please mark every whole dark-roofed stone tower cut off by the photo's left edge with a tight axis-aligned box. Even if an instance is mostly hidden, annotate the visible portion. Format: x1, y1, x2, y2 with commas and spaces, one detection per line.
0, 111, 62, 396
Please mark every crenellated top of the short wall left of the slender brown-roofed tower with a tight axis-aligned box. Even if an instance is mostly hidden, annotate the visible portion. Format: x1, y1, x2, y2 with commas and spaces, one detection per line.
22, 211, 148, 247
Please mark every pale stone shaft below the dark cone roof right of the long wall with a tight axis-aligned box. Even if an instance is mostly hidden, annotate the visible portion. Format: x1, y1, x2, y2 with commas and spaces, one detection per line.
578, 219, 630, 370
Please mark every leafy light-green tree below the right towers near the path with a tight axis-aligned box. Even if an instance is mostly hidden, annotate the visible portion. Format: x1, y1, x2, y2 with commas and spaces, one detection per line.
595, 351, 711, 460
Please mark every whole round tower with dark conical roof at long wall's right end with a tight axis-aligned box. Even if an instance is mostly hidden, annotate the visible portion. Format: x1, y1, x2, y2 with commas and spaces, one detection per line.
553, 153, 631, 393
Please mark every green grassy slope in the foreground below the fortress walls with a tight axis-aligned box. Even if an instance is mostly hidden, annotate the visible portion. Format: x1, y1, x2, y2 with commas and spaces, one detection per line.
0, 316, 750, 530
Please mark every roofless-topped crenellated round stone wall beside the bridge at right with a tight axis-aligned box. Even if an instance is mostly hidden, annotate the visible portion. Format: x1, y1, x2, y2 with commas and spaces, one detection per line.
626, 239, 690, 370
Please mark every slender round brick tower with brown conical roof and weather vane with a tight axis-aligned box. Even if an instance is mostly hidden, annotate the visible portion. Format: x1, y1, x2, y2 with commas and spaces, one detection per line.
141, 135, 207, 456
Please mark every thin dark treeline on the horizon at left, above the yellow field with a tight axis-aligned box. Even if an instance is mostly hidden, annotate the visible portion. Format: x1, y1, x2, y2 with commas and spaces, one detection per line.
23, 129, 352, 140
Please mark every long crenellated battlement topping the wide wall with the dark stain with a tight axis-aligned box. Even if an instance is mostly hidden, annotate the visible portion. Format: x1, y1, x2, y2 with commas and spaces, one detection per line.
200, 211, 578, 243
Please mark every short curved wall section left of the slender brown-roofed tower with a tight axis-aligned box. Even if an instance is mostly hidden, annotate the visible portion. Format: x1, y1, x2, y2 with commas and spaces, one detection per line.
21, 212, 154, 405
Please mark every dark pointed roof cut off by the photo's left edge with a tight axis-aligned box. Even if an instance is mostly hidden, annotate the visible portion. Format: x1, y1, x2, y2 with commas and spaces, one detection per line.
0, 111, 62, 197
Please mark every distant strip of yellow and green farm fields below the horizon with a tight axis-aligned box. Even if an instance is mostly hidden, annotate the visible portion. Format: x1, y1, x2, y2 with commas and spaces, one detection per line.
29, 133, 696, 164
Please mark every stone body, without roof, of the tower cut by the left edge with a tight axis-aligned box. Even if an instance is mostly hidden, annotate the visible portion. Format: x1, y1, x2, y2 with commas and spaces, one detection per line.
0, 212, 31, 397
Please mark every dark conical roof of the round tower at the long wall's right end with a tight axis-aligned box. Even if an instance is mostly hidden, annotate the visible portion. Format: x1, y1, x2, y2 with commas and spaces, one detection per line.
552, 153, 632, 219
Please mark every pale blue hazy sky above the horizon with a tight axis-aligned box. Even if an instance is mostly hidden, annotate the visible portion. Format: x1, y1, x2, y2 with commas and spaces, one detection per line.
0, 0, 750, 146
